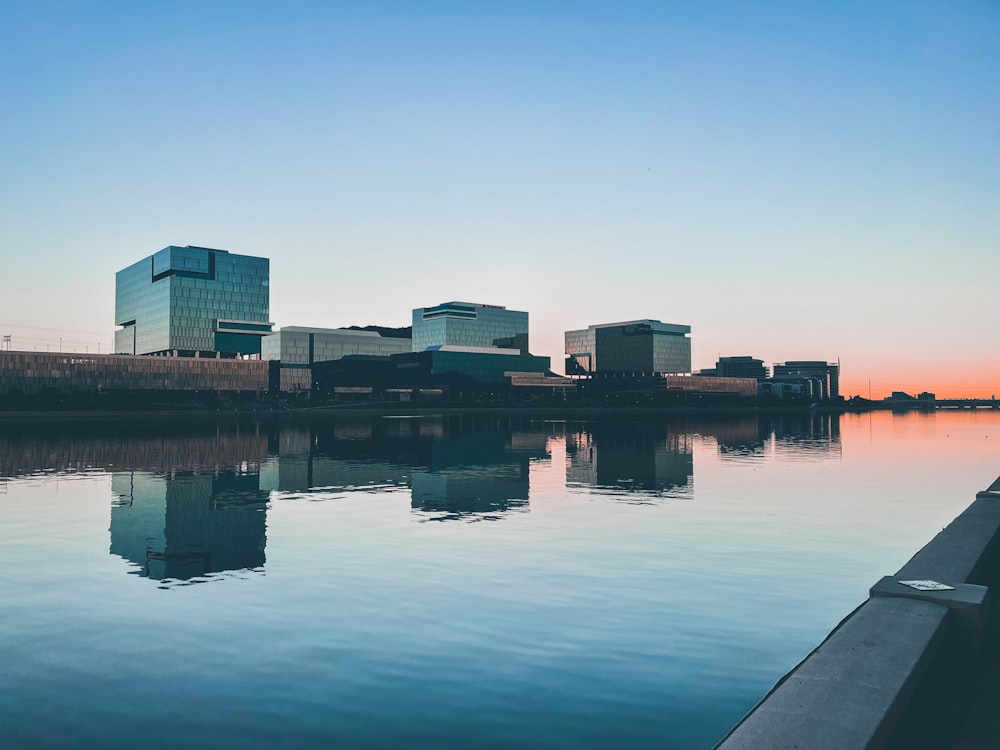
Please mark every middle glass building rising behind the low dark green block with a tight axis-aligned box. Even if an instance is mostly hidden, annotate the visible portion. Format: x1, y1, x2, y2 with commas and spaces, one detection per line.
413, 302, 528, 354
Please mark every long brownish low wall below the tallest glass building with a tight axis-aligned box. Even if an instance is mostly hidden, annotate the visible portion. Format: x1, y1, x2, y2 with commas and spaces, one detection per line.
0, 351, 268, 396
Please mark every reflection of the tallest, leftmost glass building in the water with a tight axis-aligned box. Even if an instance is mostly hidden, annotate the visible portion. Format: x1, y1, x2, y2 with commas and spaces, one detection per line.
110, 472, 267, 580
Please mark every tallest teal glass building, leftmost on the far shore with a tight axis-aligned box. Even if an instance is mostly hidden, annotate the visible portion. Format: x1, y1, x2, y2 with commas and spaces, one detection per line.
115, 245, 273, 357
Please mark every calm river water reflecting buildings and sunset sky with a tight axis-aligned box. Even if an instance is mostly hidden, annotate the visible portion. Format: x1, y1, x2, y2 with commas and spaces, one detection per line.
0, 411, 1000, 748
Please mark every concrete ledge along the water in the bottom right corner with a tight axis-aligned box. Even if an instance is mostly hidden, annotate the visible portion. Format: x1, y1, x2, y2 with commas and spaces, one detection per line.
716, 477, 1000, 750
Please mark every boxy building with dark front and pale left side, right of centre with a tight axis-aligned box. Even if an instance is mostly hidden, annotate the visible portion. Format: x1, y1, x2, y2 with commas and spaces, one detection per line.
565, 319, 691, 375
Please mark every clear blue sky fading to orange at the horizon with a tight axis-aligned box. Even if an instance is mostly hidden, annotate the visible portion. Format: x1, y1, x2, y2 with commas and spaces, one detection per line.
0, 0, 1000, 398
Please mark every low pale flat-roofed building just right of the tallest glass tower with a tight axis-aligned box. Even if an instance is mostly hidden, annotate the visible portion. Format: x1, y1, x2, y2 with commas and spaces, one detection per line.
261, 326, 411, 391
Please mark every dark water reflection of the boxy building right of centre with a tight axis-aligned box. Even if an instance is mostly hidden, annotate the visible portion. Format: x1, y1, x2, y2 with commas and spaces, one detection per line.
566, 422, 694, 494
